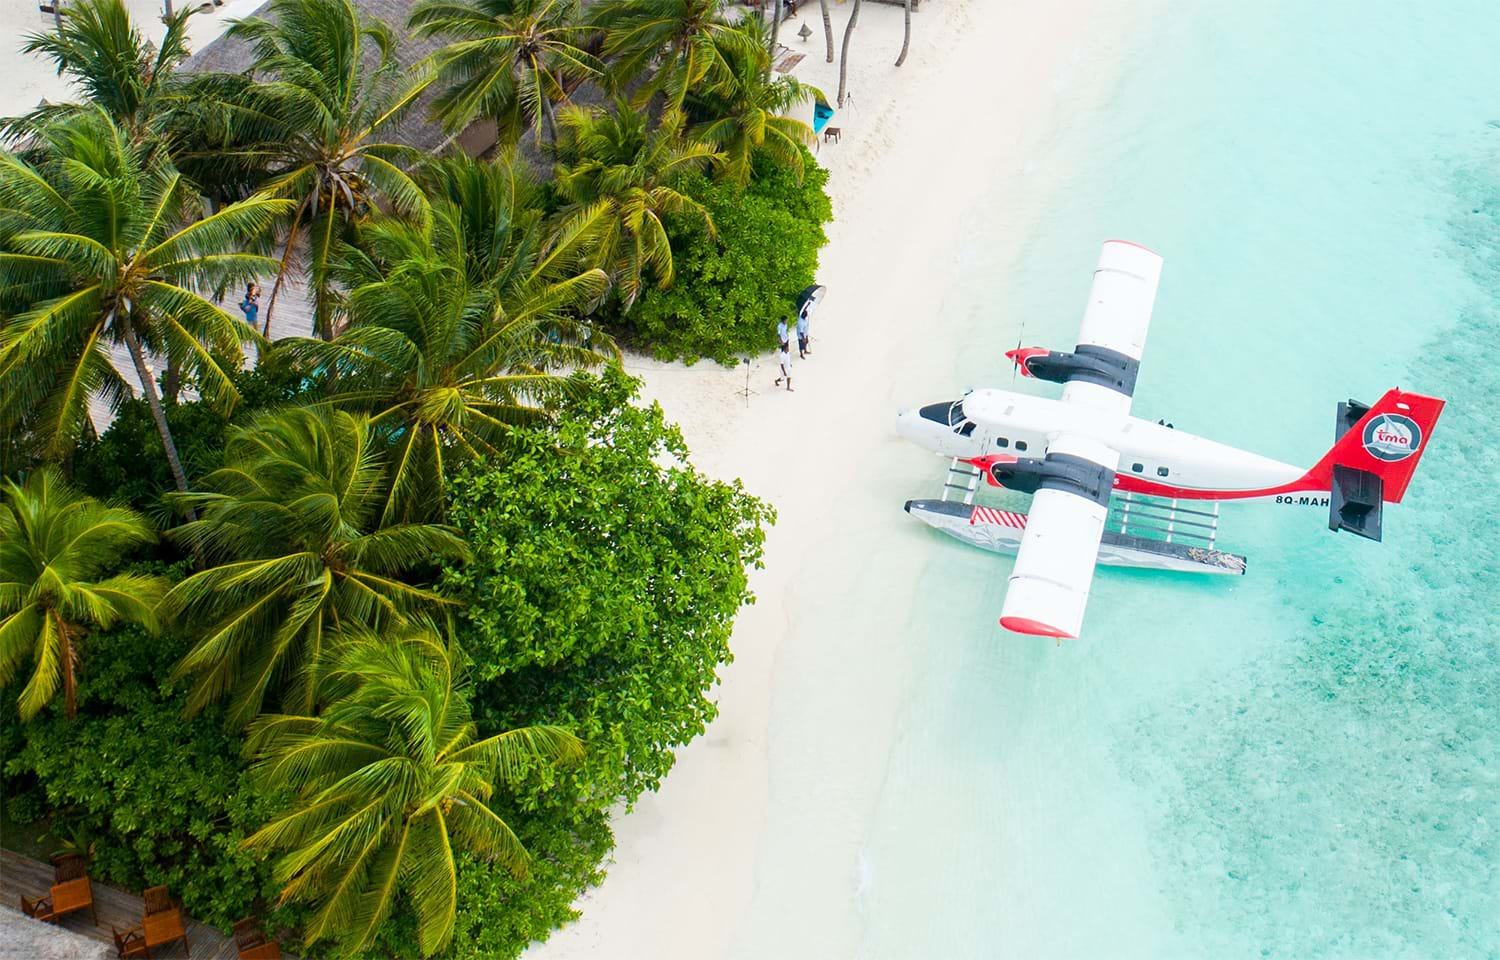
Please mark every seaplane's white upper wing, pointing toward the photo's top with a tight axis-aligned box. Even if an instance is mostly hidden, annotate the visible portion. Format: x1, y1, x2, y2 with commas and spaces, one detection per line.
1062, 240, 1163, 416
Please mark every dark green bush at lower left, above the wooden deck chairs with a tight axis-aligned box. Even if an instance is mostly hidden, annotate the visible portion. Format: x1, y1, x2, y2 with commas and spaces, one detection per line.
0, 627, 276, 927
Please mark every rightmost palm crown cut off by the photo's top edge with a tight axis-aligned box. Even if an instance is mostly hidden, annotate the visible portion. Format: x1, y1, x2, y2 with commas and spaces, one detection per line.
594, 0, 744, 110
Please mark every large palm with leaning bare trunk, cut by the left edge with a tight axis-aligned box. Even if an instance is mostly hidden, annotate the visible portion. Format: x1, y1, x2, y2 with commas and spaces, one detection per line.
0, 110, 290, 491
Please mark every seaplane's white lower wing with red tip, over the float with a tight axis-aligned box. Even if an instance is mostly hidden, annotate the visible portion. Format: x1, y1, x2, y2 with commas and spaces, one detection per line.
1001, 434, 1119, 639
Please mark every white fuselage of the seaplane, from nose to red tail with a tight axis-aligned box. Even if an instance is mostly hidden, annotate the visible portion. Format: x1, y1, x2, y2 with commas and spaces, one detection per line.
897, 390, 1307, 498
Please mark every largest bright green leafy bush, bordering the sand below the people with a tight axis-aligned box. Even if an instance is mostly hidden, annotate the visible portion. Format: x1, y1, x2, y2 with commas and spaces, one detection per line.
417, 369, 774, 959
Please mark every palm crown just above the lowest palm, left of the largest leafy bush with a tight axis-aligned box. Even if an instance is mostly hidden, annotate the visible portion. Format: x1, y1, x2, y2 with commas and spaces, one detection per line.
162, 408, 467, 725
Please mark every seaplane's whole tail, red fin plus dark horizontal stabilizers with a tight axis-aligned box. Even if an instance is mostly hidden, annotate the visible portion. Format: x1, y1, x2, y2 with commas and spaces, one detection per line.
1308, 389, 1443, 540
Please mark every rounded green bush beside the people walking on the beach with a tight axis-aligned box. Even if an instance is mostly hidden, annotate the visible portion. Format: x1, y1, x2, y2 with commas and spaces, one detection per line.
608, 150, 833, 363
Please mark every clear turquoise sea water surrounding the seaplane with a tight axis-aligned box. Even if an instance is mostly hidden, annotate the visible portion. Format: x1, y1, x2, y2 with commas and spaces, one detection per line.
756, 0, 1500, 960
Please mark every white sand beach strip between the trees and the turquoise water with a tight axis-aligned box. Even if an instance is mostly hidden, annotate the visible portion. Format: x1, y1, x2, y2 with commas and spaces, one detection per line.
540, 0, 1140, 960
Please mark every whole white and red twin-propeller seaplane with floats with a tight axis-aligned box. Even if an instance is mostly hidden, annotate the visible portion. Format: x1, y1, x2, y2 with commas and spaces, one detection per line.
897, 240, 1443, 642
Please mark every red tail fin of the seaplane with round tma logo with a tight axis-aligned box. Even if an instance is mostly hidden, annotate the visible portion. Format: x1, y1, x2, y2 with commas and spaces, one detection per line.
1308, 389, 1443, 504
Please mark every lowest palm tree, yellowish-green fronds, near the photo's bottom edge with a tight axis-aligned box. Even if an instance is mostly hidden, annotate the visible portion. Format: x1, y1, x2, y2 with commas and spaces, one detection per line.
245, 629, 584, 956
